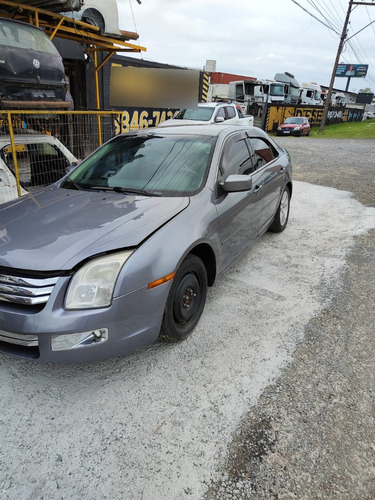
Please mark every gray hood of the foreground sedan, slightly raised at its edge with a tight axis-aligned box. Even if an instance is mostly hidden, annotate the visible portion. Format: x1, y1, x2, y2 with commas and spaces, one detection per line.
0, 186, 189, 271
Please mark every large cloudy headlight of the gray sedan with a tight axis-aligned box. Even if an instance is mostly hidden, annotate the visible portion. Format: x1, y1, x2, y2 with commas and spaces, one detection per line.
65, 250, 134, 309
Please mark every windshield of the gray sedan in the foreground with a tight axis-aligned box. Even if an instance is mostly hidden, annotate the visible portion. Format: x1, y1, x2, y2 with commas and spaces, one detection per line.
63, 134, 214, 196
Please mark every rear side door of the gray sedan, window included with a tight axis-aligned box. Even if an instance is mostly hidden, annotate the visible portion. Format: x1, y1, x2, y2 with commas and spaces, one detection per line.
248, 136, 286, 231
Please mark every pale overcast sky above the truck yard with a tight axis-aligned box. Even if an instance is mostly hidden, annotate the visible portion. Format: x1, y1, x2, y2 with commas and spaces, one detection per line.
117, 0, 375, 92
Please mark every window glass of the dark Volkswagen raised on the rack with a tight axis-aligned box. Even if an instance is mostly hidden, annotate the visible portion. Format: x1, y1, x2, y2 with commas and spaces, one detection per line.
0, 19, 58, 54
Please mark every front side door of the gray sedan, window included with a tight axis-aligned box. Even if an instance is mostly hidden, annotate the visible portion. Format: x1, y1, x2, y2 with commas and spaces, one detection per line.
216, 132, 262, 268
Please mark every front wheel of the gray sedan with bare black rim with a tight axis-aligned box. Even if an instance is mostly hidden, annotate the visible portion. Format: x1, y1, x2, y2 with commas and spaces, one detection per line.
159, 254, 207, 342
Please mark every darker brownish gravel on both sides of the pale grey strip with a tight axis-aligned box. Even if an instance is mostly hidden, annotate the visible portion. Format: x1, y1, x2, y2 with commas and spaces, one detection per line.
205, 137, 375, 500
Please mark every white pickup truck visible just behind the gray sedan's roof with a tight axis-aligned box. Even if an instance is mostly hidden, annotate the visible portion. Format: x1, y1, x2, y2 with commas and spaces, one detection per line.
159, 102, 254, 127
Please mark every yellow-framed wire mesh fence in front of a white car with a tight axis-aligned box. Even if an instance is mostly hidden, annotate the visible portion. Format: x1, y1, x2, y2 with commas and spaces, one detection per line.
0, 110, 122, 204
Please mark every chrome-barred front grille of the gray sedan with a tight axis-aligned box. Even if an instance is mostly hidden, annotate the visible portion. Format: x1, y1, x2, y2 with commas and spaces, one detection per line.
0, 272, 59, 306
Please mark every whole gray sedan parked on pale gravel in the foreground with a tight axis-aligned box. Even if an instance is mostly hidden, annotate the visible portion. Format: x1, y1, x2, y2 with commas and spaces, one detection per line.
0, 125, 292, 363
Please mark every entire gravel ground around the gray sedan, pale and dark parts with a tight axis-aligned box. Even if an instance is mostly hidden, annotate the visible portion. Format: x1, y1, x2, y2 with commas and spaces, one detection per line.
0, 137, 375, 500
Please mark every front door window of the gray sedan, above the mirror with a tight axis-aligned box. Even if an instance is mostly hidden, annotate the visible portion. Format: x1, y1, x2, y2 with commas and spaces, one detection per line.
220, 134, 253, 179
